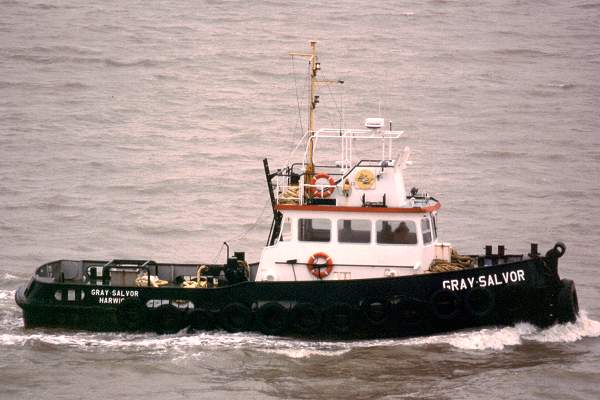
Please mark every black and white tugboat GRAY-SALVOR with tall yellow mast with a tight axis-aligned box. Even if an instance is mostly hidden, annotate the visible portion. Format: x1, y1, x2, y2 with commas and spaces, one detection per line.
15, 42, 579, 340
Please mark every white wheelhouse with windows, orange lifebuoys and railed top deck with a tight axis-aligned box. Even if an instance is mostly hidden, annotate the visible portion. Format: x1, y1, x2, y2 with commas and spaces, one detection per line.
256, 123, 440, 281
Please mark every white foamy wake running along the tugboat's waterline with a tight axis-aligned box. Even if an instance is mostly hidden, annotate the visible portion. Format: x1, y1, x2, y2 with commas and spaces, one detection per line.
0, 312, 600, 359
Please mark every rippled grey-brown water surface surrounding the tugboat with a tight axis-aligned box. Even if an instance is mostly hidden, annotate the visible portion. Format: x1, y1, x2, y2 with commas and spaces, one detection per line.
0, 0, 600, 400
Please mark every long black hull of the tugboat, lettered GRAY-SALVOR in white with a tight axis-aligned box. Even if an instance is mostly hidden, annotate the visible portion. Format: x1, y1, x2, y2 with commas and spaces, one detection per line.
16, 247, 578, 339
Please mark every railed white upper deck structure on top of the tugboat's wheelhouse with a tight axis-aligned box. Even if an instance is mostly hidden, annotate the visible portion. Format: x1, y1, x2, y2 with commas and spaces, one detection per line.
274, 124, 439, 212
